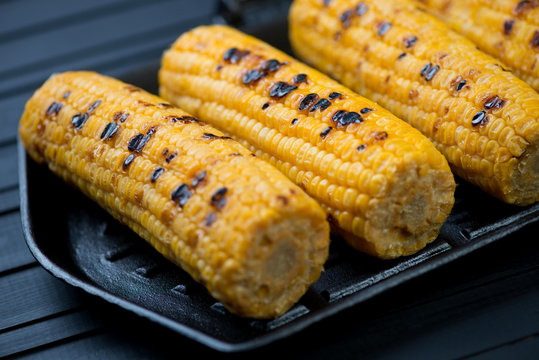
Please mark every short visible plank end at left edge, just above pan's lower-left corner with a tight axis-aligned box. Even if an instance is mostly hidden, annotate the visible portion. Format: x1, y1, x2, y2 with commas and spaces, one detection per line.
0, 211, 35, 274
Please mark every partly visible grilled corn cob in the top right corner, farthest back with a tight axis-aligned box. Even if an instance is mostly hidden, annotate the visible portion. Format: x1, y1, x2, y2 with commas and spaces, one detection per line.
418, 0, 539, 91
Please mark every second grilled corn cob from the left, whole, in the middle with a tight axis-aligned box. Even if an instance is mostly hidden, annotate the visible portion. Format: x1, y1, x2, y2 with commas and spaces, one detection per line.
159, 25, 455, 259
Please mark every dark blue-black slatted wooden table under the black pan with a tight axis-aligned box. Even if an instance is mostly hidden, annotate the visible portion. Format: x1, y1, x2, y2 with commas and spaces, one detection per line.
0, 0, 539, 359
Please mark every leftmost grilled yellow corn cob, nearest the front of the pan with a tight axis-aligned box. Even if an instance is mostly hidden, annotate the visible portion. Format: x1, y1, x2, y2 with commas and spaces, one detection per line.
20, 72, 329, 318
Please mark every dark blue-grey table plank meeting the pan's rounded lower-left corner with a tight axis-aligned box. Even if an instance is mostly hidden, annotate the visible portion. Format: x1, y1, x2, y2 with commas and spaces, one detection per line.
0, 266, 83, 332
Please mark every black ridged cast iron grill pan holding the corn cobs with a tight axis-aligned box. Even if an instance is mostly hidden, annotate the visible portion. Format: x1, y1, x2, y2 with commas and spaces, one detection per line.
19, 2, 539, 352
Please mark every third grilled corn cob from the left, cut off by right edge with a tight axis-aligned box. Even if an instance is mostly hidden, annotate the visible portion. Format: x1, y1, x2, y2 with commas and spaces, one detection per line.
289, 0, 539, 205
